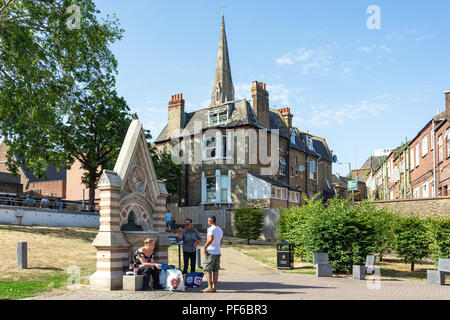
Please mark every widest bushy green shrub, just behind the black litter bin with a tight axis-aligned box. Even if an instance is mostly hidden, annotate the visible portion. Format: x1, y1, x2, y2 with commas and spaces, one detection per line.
279, 198, 392, 273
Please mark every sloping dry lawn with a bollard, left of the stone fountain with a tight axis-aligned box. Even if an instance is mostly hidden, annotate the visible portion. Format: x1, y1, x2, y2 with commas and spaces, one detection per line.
0, 225, 97, 299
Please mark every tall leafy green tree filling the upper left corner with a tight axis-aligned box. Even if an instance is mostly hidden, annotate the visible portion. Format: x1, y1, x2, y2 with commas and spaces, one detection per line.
0, 0, 129, 208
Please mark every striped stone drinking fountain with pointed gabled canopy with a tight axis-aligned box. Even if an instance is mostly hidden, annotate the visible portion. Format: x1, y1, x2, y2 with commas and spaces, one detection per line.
90, 116, 170, 290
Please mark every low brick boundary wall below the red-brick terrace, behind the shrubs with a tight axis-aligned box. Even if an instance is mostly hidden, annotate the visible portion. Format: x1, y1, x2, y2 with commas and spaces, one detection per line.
374, 197, 450, 216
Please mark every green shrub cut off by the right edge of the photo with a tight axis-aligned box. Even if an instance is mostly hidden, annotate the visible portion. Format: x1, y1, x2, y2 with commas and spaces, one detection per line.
431, 217, 450, 261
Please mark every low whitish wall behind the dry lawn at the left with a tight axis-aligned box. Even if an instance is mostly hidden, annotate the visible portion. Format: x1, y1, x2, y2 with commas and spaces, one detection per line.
0, 207, 100, 228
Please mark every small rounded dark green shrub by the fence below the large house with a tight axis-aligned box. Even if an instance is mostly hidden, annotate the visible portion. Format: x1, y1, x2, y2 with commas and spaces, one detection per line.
234, 208, 264, 244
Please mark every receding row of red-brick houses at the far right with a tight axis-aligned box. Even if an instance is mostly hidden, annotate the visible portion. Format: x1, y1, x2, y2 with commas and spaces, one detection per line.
367, 91, 450, 200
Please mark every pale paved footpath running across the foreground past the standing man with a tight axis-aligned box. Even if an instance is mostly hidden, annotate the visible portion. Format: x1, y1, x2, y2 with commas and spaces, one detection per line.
27, 248, 450, 301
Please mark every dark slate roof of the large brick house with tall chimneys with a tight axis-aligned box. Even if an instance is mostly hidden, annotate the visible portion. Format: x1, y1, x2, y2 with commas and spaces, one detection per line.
154, 100, 333, 162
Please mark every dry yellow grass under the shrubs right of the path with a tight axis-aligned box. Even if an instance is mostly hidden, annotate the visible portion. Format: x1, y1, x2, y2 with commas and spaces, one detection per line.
226, 242, 436, 281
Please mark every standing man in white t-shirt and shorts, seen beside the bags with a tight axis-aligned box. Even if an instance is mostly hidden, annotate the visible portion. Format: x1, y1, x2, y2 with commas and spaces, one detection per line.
203, 216, 223, 292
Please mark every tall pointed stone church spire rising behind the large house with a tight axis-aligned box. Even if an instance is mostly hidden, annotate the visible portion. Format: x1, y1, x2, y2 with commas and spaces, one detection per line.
211, 14, 234, 107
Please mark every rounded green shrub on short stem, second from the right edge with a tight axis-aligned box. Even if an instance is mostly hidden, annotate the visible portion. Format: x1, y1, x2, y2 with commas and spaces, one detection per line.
393, 216, 432, 271
